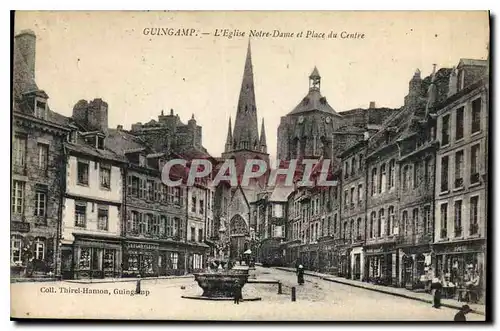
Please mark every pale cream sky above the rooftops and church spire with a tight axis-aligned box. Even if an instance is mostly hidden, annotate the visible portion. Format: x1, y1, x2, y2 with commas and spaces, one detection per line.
15, 11, 489, 164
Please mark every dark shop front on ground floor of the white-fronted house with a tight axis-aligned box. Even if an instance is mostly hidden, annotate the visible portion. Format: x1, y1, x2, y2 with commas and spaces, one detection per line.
61, 234, 122, 279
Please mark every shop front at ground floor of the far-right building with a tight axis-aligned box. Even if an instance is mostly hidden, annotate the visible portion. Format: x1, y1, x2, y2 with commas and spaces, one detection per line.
433, 239, 486, 302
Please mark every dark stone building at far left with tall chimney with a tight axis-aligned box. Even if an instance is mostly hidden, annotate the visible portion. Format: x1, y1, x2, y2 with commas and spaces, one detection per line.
10, 30, 69, 278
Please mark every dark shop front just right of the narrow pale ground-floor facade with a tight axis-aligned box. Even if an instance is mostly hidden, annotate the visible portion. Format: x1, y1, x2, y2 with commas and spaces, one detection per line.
363, 243, 398, 286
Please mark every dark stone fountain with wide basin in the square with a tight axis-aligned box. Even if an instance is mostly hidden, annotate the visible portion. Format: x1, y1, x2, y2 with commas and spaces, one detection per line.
182, 217, 261, 301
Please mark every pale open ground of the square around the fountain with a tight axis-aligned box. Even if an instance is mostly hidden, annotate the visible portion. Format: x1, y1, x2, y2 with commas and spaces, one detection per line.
11, 267, 485, 321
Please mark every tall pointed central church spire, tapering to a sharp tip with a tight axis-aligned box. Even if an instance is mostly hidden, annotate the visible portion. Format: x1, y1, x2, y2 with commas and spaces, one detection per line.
233, 40, 259, 150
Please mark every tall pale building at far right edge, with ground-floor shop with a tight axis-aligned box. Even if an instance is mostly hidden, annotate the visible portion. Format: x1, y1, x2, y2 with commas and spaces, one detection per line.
433, 59, 489, 299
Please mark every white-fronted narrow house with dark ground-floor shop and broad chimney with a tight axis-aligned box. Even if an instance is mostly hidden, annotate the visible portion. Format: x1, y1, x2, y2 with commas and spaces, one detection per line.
60, 99, 126, 279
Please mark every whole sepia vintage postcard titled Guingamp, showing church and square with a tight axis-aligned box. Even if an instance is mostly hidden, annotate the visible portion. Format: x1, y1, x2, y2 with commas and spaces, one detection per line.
10, 11, 492, 322
